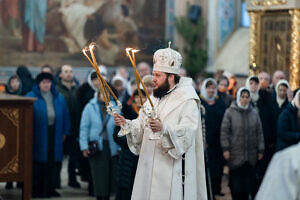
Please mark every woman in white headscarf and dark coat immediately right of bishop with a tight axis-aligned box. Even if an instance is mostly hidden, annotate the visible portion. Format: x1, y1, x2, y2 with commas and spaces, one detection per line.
200, 78, 226, 196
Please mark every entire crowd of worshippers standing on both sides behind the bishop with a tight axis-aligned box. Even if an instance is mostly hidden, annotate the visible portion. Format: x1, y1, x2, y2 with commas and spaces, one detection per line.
1, 58, 300, 200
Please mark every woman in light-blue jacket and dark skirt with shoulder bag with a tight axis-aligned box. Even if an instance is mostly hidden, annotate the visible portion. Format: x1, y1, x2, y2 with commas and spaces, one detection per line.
79, 91, 119, 200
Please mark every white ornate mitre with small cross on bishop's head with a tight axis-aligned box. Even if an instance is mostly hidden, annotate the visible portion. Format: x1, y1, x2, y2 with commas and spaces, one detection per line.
153, 43, 182, 74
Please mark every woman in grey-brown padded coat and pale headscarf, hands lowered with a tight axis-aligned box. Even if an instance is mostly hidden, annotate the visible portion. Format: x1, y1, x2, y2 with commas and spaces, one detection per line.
221, 87, 264, 200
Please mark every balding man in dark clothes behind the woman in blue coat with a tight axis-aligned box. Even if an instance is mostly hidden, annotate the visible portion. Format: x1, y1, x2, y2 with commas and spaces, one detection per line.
56, 65, 80, 188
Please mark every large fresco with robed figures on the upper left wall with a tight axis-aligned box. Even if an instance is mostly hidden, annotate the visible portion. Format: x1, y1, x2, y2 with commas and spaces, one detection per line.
0, 0, 165, 66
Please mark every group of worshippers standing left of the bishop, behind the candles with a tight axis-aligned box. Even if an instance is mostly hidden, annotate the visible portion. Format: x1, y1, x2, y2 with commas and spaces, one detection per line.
5, 62, 154, 199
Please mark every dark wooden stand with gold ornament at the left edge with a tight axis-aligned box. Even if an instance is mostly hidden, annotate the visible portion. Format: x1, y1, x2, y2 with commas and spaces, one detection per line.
0, 92, 35, 200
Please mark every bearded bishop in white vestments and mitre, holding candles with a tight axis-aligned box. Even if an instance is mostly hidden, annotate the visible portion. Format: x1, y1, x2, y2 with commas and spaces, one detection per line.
114, 48, 207, 200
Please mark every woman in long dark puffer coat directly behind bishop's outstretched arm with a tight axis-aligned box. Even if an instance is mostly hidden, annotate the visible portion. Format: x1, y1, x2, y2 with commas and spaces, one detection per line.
114, 90, 146, 200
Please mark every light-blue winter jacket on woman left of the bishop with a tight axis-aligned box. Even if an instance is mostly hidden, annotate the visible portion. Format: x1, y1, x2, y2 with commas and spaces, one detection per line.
79, 96, 119, 156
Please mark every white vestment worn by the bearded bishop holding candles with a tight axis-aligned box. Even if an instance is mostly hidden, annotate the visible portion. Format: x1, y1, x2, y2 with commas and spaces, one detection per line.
126, 77, 207, 200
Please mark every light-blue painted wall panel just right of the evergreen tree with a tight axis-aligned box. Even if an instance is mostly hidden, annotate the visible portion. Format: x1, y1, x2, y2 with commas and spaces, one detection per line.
218, 0, 235, 48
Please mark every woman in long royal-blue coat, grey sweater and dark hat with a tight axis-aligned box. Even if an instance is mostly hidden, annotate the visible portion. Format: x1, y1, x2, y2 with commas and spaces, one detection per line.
26, 72, 70, 197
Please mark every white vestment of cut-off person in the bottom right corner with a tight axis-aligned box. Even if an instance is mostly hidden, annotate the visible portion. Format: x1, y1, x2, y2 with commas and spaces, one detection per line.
255, 143, 300, 200
